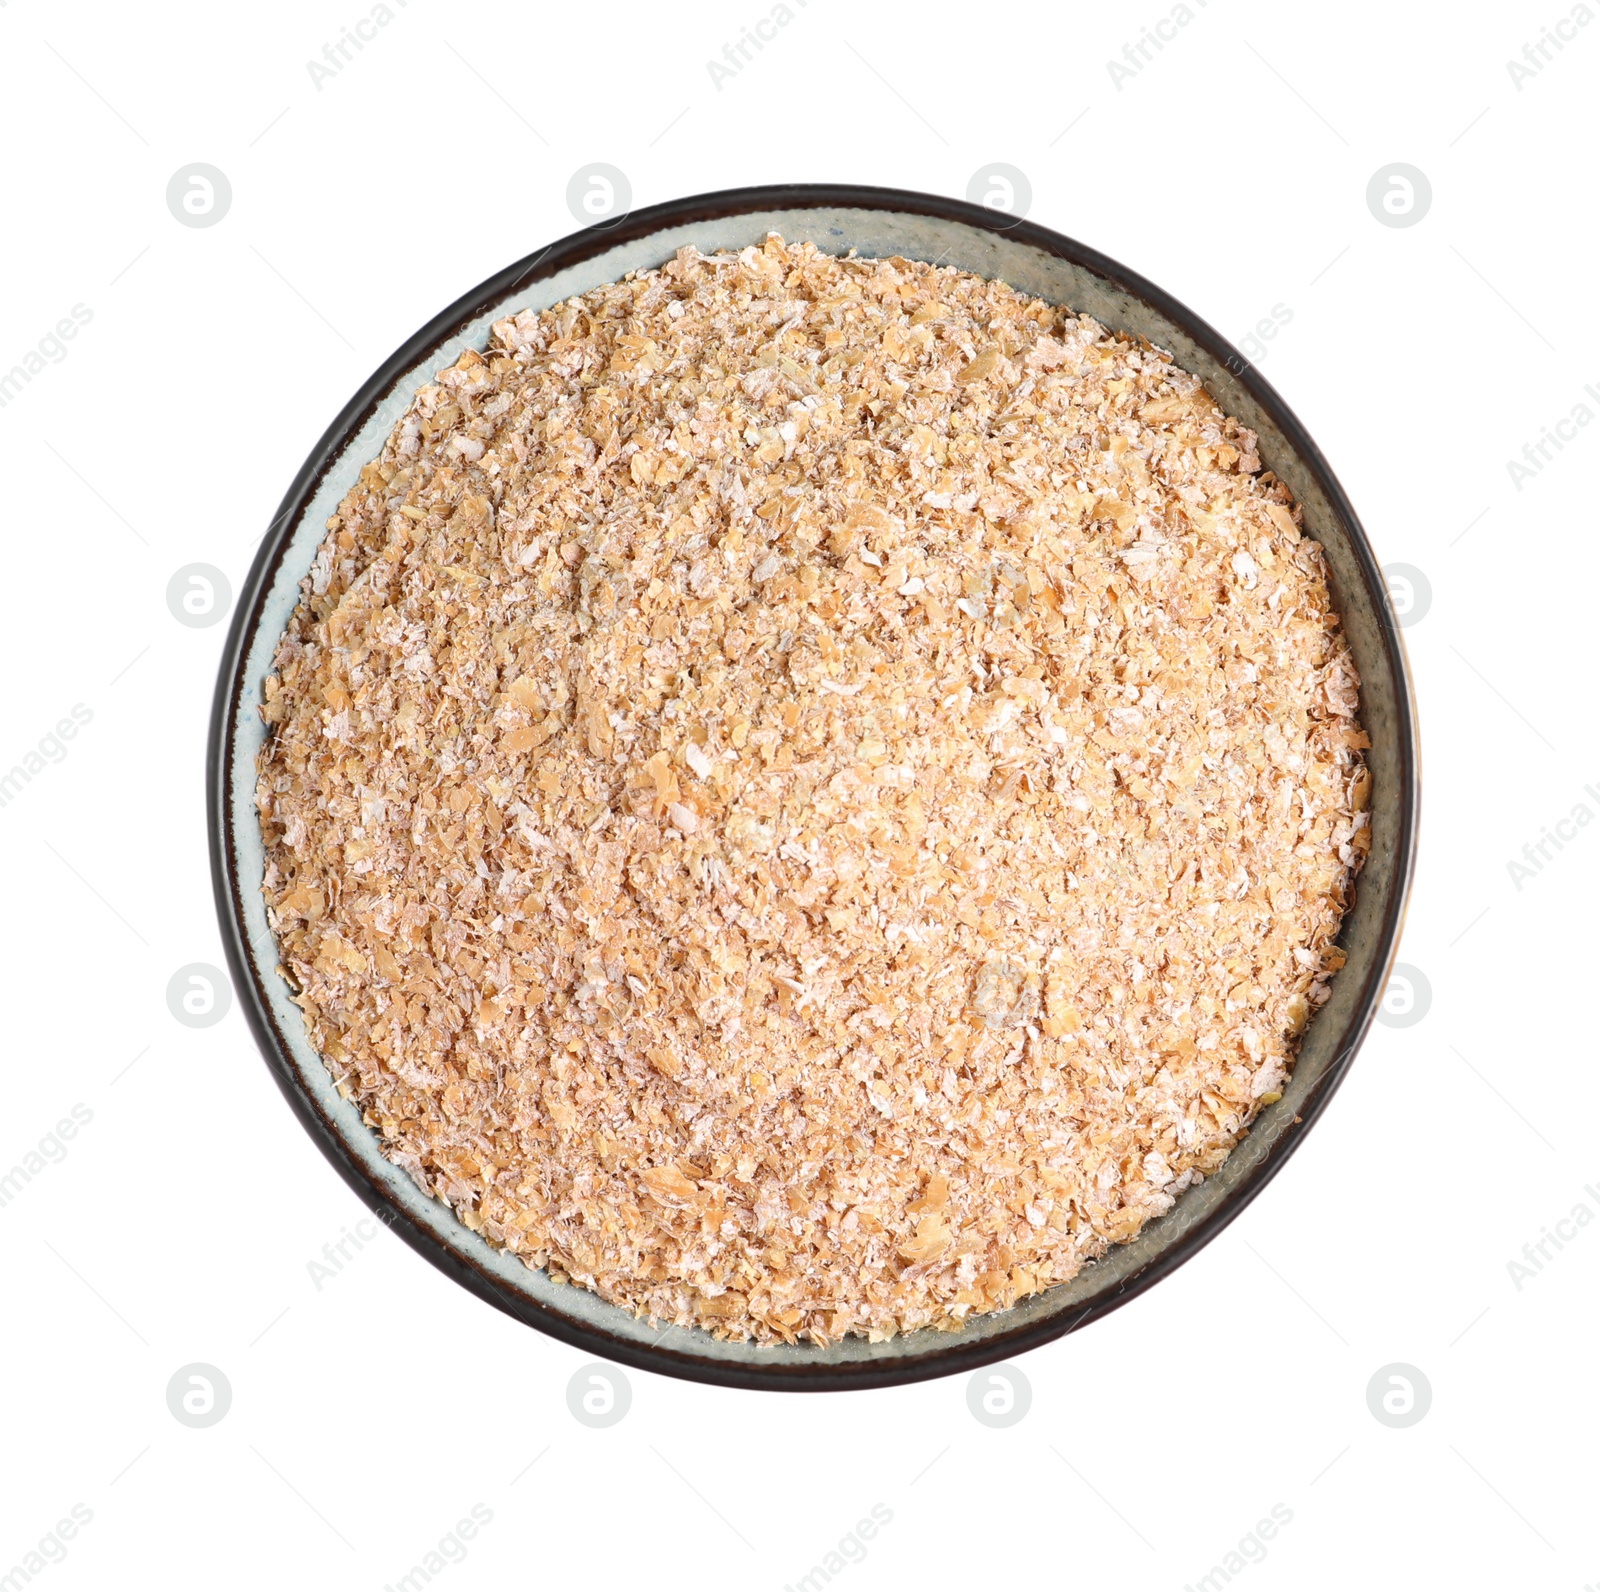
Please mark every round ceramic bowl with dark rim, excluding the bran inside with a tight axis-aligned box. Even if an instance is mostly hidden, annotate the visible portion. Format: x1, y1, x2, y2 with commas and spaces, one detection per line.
206, 184, 1418, 1390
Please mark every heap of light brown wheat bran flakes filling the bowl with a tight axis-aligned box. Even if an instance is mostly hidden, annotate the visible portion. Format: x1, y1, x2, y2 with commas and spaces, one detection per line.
258, 237, 1370, 1342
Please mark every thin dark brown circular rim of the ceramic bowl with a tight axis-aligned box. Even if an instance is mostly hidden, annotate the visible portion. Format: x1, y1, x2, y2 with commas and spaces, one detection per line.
206, 182, 1421, 1392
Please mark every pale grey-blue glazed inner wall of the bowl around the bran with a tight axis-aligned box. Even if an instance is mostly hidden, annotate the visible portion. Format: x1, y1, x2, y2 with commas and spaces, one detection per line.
230, 208, 1406, 1366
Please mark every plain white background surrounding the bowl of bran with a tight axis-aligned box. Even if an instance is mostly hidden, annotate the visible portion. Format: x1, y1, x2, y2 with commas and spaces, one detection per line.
0, 0, 1600, 1592
